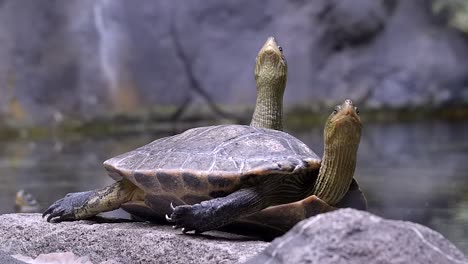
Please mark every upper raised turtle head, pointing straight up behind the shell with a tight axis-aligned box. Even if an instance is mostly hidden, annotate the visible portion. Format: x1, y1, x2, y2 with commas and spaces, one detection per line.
255, 37, 288, 94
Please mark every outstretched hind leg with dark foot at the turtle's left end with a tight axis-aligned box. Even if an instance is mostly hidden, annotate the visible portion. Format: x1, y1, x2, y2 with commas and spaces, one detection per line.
42, 179, 141, 222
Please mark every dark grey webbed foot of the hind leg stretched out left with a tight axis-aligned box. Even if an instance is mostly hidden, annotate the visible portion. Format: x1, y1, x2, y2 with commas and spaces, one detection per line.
42, 191, 94, 222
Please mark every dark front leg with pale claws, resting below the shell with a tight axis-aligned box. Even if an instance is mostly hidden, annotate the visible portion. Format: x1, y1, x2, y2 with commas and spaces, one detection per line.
166, 188, 271, 233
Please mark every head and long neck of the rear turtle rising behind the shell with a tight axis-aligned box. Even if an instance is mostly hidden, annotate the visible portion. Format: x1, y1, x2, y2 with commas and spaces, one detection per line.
250, 37, 288, 130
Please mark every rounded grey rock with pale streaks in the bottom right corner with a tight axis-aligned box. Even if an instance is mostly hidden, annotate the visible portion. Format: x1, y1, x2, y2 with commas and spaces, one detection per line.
247, 209, 468, 264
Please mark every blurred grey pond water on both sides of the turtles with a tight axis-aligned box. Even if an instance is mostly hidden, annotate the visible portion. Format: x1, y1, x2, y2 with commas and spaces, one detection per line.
0, 121, 468, 254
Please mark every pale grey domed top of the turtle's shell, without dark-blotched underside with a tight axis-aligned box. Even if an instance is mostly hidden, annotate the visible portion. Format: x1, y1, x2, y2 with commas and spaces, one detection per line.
104, 125, 320, 187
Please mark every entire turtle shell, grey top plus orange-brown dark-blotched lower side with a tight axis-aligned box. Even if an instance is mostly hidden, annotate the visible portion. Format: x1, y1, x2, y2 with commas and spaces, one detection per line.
104, 125, 321, 204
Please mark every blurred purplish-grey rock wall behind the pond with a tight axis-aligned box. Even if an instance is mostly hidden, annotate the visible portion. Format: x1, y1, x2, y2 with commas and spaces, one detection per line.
0, 0, 468, 126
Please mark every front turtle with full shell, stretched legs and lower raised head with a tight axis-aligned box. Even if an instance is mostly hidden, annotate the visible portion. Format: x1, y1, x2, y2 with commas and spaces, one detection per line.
43, 100, 365, 233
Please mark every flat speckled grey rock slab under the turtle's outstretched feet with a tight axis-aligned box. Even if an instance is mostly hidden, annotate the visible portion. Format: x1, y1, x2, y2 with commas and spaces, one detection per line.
0, 214, 268, 264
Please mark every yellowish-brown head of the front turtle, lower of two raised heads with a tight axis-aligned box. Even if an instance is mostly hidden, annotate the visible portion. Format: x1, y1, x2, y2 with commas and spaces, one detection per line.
324, 99, 362, 147
